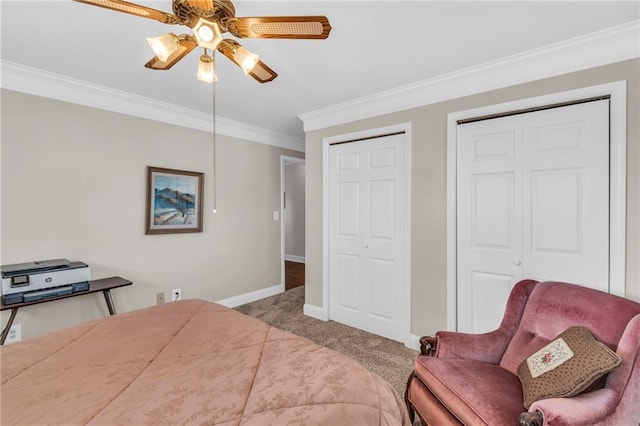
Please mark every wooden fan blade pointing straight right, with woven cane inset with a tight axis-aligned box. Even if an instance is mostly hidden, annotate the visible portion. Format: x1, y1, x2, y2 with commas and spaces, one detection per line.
227, 16, 331, 39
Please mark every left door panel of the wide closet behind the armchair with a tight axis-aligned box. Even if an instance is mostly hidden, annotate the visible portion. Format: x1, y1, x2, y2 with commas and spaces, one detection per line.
457, 116, 522, 332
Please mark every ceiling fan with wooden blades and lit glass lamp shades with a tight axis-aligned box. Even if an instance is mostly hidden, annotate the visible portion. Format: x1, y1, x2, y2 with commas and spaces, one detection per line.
74, 0, 331, 83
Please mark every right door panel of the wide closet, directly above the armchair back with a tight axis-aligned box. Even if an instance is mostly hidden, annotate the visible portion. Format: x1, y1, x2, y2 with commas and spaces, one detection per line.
522, 100, 609, 292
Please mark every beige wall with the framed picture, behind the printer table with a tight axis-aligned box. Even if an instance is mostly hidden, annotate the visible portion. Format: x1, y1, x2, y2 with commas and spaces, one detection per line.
1, 90, 303, 337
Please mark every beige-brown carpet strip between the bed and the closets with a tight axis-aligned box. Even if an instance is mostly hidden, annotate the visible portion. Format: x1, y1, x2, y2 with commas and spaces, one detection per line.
236, 286, 418, 397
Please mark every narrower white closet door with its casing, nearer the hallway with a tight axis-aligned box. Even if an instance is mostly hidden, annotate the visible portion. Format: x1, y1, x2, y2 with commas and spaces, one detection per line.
323, 125, 410, 344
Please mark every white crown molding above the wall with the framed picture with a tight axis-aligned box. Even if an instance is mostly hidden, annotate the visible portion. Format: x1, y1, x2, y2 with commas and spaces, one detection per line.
0, 60, 304, 152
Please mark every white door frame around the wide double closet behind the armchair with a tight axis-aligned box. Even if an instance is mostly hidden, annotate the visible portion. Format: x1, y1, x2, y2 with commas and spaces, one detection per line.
447, 80, 627, 331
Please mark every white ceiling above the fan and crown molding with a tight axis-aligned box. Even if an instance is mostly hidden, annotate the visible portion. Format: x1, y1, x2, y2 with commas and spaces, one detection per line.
0, 0, 640, 139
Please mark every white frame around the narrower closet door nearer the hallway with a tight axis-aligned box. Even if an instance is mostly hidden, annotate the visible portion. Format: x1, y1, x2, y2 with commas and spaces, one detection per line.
316, 123, 411, 346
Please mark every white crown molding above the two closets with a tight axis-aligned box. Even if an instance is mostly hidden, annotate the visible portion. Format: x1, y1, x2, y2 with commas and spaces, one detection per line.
298, 20, 640, 132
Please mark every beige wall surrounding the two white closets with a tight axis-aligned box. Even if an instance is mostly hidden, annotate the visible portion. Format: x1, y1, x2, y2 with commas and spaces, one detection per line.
305, 59, 640, 335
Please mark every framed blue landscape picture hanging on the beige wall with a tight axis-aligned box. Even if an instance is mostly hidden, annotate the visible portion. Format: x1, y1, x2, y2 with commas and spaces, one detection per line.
145, 166, 204, 234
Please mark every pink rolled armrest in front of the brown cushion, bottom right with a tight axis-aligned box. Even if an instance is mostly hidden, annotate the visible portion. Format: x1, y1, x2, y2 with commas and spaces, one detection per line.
518, 388, 617, 426
